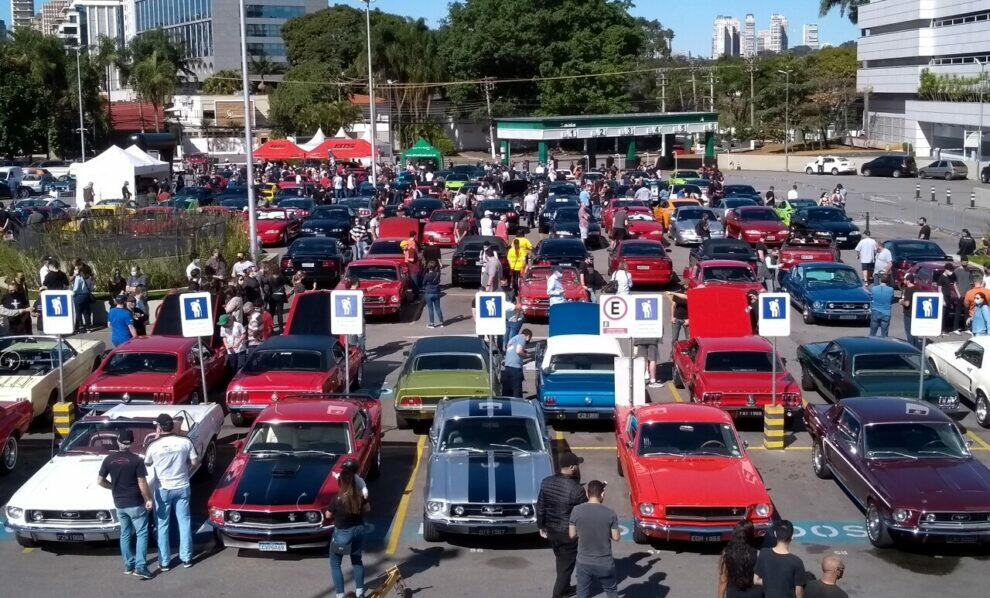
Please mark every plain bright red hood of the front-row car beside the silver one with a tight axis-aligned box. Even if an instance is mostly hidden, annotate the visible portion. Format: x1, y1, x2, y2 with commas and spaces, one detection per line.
633, 457, 770, 507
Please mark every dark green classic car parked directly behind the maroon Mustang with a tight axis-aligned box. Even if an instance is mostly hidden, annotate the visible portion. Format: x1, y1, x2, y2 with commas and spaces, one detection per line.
797, 336, 967, 419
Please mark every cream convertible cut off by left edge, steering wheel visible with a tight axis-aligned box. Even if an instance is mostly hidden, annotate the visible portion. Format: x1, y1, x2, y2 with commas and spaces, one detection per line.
0, 336, 106, 417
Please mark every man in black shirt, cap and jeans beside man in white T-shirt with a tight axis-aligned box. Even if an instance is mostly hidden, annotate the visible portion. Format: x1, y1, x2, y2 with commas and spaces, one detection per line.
96, 430, 152, 579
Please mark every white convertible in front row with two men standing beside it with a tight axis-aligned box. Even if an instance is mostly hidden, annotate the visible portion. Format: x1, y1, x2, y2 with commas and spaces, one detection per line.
6, 403, 224, 547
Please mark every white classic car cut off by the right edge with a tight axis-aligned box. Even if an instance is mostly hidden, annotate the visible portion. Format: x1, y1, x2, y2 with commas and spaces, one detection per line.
925, 336, 990, 428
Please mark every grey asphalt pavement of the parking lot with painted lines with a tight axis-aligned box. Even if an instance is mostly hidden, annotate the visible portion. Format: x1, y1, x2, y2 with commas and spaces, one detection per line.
0, 172, 990, 598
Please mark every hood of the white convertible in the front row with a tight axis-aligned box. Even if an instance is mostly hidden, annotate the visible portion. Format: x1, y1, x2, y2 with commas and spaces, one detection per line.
9, 455, 114, 511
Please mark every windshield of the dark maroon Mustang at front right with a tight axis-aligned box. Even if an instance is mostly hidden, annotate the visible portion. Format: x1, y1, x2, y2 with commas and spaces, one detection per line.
865, 422, 970, 459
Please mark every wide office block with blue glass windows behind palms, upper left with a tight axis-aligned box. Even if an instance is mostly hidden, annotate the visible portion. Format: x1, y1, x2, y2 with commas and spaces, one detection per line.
134, 0, 327, 79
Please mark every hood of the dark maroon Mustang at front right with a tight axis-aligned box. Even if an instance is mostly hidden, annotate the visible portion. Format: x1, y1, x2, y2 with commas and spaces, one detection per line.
868, 459, 990, 511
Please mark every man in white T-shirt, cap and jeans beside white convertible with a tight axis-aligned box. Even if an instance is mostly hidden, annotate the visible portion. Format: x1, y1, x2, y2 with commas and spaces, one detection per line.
144, 413, 199, 573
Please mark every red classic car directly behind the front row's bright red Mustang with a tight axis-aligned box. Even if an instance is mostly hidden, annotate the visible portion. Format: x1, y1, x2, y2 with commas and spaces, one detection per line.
673, 338, 801, 417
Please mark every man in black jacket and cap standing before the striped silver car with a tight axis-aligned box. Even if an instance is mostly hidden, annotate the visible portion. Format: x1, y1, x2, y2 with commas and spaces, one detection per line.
536, 452, 588, 598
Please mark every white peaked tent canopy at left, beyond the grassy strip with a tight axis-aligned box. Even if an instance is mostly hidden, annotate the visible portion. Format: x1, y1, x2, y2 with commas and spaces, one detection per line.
72, 145, 169, 208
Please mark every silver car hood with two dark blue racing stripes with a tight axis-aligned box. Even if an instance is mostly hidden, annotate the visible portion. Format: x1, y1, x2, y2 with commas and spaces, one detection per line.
426, 451, 553, 503
